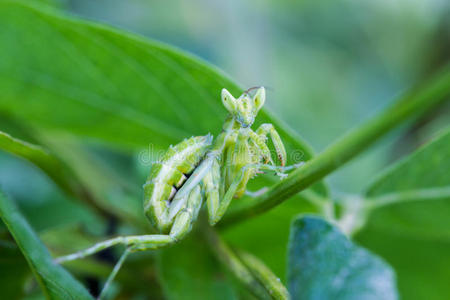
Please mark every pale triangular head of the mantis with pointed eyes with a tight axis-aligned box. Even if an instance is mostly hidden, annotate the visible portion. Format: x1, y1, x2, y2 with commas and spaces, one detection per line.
222, 87, 266, 128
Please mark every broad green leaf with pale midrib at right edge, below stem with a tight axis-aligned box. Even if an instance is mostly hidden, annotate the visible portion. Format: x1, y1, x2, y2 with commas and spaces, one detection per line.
355, 129, 450, 300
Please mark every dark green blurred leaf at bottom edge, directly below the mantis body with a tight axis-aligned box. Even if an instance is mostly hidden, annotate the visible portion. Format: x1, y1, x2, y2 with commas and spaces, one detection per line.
158, 233, 237, 300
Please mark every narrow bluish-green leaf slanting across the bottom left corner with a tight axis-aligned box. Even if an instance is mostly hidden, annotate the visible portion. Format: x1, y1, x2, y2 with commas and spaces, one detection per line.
0, 194, 93, 300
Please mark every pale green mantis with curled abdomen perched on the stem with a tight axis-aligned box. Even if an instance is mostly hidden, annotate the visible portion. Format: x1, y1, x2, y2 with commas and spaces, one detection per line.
57, 87, 296, 297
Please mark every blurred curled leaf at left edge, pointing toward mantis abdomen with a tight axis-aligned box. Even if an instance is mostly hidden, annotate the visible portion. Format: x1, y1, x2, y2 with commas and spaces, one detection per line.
0, 125, 149, 229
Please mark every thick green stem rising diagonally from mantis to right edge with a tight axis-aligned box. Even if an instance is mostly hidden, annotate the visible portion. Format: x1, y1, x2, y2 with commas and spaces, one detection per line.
222, 65, 450, 225
